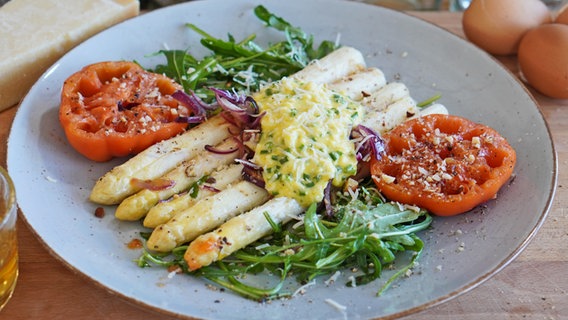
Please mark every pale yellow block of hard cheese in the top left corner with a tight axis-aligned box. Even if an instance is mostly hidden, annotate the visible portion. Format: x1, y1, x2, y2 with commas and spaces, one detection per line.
0, 0, 140, 111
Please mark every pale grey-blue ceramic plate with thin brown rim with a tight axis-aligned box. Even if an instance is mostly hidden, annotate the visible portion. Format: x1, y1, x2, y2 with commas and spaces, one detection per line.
8, 0, 557, 319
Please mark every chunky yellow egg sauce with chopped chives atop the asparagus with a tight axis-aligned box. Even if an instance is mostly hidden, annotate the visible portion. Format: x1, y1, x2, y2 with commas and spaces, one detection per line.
253, 78, 363, 206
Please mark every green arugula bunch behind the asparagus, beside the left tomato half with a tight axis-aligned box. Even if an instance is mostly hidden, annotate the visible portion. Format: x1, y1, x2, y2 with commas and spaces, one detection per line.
149, 6, 338, 102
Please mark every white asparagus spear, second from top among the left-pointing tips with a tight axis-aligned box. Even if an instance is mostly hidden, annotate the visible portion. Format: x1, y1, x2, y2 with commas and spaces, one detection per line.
115, 137, 240, 221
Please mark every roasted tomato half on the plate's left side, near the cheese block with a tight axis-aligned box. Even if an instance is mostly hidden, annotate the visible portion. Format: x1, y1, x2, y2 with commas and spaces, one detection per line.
59, 61, 191, 161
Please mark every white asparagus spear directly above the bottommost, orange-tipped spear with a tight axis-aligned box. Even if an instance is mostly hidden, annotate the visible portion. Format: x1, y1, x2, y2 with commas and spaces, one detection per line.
147, 181, 270, 252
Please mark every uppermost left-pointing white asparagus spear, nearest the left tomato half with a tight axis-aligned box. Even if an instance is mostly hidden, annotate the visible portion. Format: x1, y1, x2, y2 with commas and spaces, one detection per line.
90, 116, 236, 205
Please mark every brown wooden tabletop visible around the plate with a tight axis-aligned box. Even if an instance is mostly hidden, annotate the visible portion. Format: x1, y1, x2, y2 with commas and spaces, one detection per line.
0, 12, 568, 320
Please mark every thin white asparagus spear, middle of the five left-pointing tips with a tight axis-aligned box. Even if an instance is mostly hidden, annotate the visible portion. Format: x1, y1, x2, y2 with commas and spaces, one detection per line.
144, 164, 243, 228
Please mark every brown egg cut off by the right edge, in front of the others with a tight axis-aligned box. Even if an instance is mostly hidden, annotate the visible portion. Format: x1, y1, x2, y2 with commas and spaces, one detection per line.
518, 23, 568, 99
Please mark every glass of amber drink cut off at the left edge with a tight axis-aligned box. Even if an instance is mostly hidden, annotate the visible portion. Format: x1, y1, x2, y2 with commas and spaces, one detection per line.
0, 167, 18, 310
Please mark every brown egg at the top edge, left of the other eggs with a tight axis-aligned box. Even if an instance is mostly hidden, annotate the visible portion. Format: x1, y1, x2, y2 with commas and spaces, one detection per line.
462, 0, 552, 55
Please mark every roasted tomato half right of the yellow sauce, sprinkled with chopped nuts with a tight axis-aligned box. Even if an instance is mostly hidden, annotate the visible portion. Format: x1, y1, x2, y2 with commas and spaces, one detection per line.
371, 115, 516, 216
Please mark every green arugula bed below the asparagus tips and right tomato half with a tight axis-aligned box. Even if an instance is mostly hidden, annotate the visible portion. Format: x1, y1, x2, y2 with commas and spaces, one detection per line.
139, 184, 432, 301
